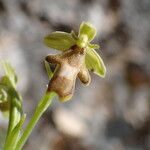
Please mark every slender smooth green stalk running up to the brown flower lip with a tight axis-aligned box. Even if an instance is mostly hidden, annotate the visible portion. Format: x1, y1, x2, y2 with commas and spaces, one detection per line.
15, 92, 56, 150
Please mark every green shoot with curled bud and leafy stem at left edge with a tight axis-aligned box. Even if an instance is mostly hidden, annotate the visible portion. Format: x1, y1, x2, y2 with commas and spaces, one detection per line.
0, 62, 25, 150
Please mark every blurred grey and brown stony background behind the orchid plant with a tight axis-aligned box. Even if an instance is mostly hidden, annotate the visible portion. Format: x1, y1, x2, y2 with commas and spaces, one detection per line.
0, 0, 150, 150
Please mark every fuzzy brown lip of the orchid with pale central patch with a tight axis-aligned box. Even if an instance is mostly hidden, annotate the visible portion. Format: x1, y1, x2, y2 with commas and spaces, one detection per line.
46, 46, 90, 102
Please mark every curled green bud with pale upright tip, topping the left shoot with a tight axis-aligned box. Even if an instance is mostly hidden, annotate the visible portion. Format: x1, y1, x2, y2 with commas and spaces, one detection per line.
0, 62, 22, 115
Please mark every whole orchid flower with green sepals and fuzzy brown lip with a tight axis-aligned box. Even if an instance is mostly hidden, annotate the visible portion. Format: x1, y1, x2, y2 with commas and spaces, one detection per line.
44, 22, 106, 102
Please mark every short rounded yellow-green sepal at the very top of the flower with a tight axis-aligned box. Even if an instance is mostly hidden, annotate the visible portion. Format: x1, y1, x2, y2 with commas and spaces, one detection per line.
79, 22, 96, 42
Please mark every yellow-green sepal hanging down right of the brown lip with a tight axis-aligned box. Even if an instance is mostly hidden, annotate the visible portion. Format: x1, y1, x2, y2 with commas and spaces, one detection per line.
85, 47, 106, 77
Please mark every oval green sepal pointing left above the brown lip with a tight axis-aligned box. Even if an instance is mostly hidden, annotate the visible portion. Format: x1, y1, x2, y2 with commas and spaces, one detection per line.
44, 31, 76, 51
